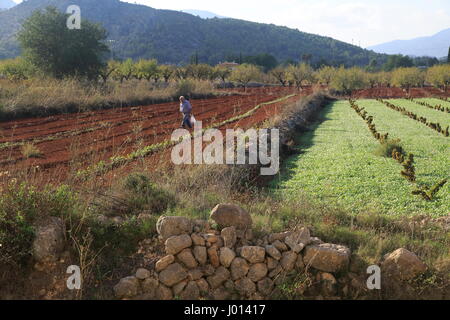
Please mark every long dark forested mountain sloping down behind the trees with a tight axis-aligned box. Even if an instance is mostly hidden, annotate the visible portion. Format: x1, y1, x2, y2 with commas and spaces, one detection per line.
0, 0, 386, 66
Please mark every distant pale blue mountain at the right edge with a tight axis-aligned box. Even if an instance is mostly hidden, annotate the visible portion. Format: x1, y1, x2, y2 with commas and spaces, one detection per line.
367, 28, 450, 57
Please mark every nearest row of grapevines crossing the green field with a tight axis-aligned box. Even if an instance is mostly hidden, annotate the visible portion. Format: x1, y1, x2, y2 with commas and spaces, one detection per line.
349, 99, 447, 201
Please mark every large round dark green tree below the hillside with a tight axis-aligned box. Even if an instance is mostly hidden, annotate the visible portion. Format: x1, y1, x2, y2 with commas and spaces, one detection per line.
18, 7, 108, 78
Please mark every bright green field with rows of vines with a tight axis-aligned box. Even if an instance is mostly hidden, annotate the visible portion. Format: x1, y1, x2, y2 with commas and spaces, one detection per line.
272, 99, 450, 216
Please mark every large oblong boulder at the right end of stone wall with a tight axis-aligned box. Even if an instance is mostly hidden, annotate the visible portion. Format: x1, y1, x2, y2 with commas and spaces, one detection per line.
303, 243, 351, 272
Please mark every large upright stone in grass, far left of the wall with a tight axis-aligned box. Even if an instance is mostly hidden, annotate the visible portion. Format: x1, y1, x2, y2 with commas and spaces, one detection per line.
33, 217, 65, 262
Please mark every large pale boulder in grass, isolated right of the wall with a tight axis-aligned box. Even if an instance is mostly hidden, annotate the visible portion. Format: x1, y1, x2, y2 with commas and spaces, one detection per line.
381, 248, 427, 280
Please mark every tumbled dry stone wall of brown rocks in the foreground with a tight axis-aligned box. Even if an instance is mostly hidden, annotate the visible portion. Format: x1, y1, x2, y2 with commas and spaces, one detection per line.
114, 204, 351, 300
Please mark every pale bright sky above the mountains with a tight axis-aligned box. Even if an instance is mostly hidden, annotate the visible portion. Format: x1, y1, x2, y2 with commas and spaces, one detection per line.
15, 0, 450, 47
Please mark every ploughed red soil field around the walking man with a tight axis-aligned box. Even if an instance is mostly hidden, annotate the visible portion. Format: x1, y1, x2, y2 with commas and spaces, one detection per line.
0, 88, 311, 180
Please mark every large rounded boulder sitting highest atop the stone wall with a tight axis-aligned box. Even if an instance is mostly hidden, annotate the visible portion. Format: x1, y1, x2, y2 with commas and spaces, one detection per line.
210, 204, 252, 230
